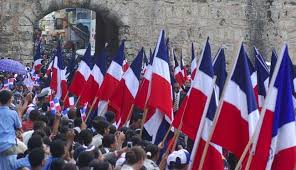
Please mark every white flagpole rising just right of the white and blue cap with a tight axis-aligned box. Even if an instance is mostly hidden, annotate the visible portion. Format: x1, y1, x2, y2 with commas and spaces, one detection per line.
189, 76, 217, 169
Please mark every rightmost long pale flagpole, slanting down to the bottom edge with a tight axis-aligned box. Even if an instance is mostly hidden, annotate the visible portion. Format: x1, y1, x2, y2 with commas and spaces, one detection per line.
235, 43, 284, 170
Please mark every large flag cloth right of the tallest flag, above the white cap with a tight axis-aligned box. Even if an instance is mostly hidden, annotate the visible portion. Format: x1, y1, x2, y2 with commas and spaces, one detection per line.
173, 40, 215, 140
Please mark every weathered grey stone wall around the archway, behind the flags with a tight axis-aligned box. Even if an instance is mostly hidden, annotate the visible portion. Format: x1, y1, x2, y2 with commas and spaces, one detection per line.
0, 0, 296, 63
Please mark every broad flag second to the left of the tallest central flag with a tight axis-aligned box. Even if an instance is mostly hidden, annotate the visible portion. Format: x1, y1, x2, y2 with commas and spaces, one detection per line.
109, 48, 144, 127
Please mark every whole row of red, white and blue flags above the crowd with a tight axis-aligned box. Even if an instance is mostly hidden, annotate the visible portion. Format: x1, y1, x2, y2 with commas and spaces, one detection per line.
35, 31, 296, 169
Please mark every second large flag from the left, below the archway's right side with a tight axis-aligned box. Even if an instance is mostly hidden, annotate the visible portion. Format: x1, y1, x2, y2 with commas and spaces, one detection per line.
69, 45, 93, 96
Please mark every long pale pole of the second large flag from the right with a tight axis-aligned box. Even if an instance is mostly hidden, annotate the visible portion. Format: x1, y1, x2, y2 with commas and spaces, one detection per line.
199, 41, 242, 170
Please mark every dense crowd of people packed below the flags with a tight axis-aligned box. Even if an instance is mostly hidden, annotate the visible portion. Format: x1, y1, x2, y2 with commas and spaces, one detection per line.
0, 41, 234, 170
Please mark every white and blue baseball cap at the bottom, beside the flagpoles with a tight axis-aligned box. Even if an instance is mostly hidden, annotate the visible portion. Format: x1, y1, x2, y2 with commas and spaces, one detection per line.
167, 149, 190, 167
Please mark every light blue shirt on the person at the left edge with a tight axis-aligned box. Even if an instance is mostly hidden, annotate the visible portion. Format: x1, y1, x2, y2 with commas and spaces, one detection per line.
0, 106, 22, 152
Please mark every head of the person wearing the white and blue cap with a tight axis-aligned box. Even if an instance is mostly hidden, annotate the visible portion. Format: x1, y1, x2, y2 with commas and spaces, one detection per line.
167, 149, 190, 170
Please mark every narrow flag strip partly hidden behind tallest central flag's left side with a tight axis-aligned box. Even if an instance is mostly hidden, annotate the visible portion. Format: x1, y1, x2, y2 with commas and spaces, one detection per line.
134, 47, 154, 110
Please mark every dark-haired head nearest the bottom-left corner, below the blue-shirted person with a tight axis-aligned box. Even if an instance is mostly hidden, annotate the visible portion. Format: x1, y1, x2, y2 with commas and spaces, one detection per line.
28, 147, 45, 170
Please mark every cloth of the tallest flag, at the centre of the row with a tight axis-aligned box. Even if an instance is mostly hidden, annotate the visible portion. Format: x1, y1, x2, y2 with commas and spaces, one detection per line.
147, 31, 173, 120
